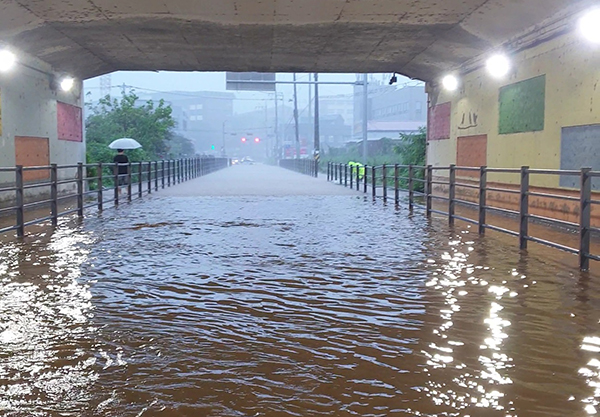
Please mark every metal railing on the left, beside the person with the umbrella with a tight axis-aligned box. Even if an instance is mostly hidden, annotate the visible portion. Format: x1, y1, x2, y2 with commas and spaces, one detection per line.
0, 158, 230, 237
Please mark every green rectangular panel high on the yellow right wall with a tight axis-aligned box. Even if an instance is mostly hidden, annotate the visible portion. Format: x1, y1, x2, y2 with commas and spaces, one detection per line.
498, 75, 546, 135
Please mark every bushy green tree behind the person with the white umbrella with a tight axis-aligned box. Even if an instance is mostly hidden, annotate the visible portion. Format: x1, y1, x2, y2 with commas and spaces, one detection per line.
85, 91, 175, 163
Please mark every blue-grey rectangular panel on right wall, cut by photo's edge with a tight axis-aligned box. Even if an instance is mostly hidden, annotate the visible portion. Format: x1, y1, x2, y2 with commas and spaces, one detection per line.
560, 124, 600, 190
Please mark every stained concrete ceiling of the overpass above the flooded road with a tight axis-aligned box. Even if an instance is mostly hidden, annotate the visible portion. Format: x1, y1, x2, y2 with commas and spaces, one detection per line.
0, 0, 593, 81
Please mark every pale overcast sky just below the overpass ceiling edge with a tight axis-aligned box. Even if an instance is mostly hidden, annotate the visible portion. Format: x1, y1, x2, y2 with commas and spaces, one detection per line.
84, 71, 416, 113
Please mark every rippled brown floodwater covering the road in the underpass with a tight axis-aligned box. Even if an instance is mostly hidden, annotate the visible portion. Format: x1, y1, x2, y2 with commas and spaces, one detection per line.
0, 195, 600, 417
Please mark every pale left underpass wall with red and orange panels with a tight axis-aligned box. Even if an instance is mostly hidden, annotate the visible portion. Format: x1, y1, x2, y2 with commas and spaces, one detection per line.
0, 52, 85, 201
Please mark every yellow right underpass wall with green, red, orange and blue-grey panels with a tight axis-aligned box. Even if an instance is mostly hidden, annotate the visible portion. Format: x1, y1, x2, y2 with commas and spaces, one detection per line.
427, 33, 600, 224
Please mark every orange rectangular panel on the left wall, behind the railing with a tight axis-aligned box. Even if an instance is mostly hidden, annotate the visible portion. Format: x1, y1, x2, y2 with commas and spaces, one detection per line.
15, 136, 50, 181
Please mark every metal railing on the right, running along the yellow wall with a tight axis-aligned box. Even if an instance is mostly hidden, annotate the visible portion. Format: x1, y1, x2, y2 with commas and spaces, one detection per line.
327, 162, 600, 271
